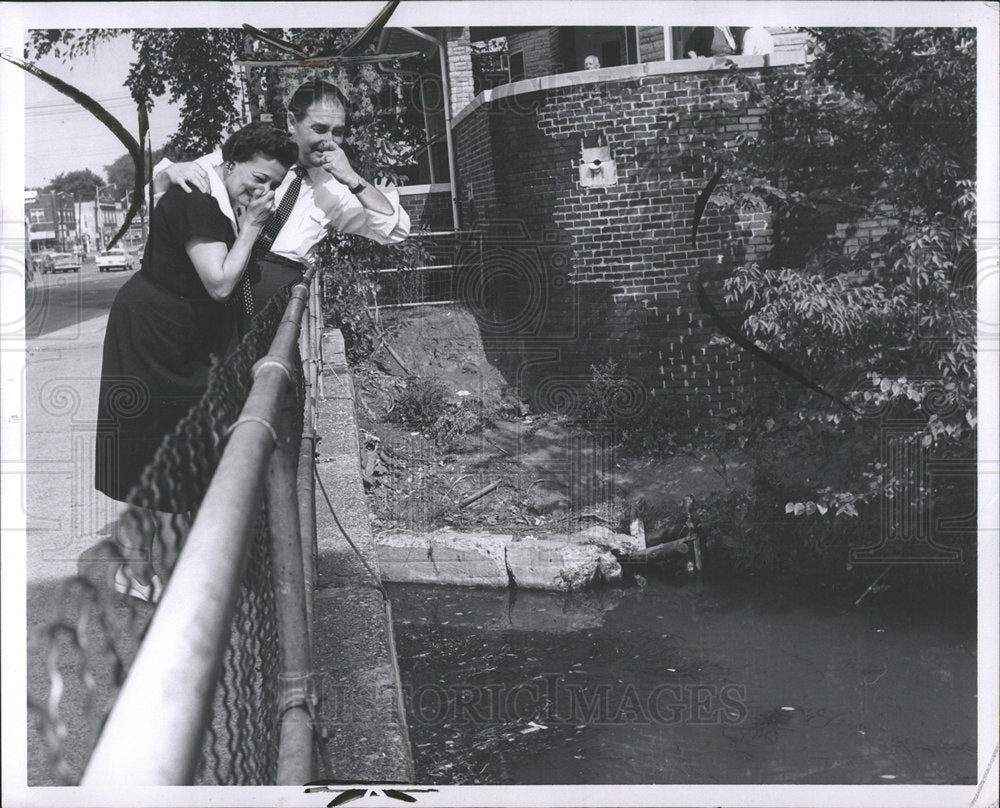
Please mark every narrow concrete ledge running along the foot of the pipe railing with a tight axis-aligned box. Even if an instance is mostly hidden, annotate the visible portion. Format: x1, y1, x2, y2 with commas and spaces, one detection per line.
313, 331, 414, 783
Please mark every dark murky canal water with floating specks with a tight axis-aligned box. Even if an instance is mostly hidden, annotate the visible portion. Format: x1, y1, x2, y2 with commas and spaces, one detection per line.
389, 574, 976, 785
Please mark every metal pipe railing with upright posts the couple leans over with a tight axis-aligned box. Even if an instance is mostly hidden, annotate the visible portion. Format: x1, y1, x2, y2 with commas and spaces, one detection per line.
74, 272, 321, 785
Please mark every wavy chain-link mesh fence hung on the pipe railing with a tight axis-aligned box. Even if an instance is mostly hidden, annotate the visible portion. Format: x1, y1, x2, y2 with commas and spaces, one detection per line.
28, 276, 319, 785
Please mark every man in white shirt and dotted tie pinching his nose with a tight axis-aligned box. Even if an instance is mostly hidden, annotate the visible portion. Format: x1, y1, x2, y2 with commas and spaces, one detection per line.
153, 79, 410, 322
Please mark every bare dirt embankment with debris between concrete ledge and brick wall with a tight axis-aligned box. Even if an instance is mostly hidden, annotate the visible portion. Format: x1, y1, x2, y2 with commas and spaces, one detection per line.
355, 306, 746, 544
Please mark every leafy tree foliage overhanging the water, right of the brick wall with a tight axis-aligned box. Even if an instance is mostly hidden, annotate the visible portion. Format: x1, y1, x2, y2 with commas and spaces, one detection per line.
715, 28, 976, 540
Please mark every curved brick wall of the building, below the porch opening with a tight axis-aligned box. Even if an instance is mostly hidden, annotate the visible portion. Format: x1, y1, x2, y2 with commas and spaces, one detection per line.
455, 57, 808, 417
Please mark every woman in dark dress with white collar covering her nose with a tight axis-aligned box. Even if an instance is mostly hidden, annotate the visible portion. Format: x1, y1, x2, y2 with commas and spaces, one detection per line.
95, 124, 298, 602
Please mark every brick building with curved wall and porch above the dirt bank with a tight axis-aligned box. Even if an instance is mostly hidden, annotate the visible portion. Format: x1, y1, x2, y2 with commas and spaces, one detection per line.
370, 26, 806, 416
